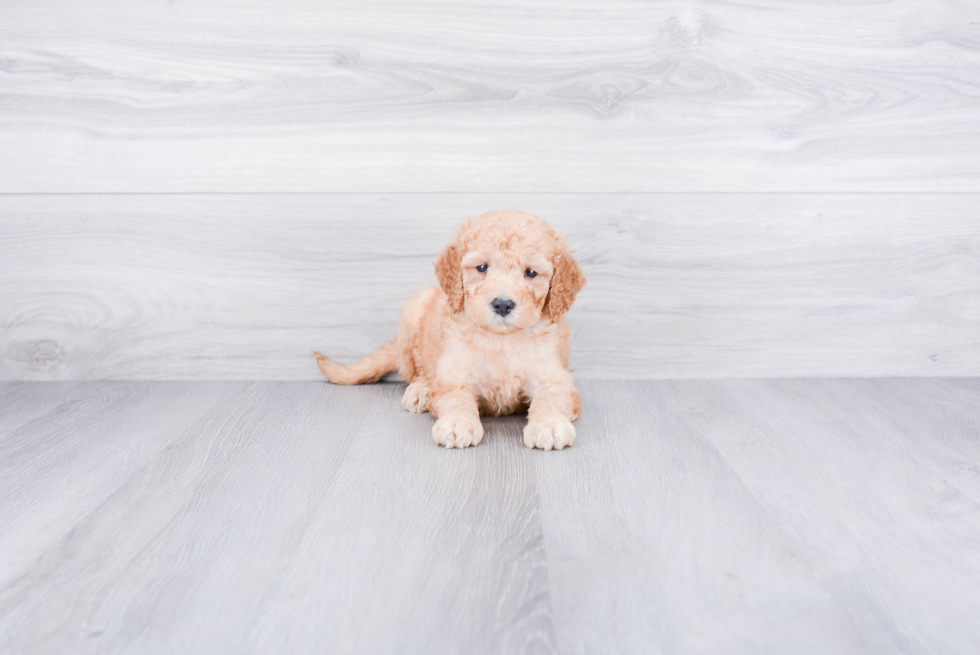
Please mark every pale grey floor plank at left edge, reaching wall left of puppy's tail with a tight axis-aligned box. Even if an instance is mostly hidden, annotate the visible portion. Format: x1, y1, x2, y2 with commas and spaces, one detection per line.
0, 383, 243, 588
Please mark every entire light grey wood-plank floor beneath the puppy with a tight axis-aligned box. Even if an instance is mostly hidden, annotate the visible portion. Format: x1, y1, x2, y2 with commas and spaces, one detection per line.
0, 379, 980, 653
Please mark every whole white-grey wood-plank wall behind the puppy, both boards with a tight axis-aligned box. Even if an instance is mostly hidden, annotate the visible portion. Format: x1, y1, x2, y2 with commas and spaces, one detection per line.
0, 0, 980, 379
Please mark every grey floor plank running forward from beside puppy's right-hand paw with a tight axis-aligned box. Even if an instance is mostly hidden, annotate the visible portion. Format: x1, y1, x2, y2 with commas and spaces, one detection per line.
536, 381, 864, 655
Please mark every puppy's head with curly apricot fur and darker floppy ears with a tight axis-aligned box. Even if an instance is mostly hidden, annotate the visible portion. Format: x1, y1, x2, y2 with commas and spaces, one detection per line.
436, 211, 585, 334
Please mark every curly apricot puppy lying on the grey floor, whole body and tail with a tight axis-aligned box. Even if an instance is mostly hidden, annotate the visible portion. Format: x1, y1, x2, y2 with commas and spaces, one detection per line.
314, 211, 585, 450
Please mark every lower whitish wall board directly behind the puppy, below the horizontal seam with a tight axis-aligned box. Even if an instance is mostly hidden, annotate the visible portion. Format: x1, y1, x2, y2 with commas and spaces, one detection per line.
0, 194, 980, 380
